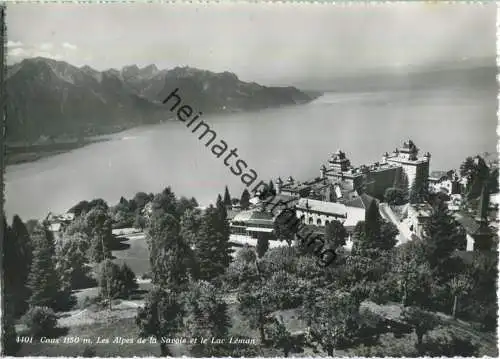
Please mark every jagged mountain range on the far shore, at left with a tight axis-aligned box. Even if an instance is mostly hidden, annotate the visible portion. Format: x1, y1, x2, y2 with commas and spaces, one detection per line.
7, 57, 315, 142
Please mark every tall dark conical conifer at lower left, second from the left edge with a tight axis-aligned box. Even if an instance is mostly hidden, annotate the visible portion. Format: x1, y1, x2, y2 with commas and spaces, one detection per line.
28, 226, 59, 308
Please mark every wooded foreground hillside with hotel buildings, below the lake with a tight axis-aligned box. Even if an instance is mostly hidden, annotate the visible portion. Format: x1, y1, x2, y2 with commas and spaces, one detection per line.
5, 140, 499, 356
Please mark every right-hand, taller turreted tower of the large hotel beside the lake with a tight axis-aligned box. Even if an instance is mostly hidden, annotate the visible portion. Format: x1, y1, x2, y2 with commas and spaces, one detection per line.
384, 140, 431, 190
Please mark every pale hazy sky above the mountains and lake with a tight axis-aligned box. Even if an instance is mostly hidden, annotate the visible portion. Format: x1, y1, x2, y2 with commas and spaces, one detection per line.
7, 2, 496, 83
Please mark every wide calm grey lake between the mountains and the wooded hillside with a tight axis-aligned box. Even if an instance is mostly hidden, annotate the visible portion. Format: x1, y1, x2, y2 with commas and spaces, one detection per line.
5, 88, 497, 221
